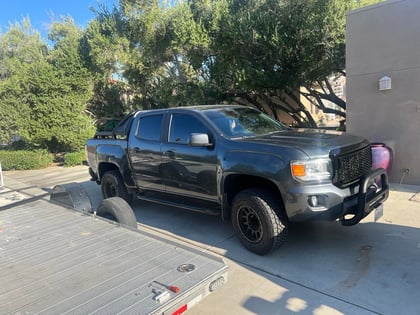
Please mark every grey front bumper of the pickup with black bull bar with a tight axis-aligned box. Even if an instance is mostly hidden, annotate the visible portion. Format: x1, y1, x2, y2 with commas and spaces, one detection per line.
283, 169, 389, 226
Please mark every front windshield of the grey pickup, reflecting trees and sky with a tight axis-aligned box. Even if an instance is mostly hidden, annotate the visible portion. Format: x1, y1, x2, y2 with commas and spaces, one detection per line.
203, 107, 288, 138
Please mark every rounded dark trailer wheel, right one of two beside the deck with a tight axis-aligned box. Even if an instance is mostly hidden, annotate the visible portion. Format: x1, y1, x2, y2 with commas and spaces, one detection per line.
96, 197, 137, 229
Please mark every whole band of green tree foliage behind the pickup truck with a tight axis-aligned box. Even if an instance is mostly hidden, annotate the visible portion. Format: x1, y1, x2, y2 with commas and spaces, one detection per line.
0, 0, 380, 152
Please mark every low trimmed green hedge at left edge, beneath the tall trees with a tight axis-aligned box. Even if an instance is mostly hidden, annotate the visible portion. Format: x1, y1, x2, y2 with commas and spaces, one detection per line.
0, 150, 53, 171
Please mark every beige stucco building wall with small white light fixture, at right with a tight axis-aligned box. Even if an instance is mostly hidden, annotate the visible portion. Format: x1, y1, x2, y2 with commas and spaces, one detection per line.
346, 0, 420, 185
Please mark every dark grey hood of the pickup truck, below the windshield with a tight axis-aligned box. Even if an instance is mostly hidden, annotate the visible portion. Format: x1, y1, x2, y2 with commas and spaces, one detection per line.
240, 129, 369, 157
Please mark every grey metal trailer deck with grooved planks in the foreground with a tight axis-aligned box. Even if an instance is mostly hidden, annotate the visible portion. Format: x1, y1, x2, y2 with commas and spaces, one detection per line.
0, 199, 227, 314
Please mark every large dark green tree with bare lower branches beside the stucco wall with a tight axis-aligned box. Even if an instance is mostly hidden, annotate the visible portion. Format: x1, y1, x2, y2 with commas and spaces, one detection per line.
186, 0, 384, 127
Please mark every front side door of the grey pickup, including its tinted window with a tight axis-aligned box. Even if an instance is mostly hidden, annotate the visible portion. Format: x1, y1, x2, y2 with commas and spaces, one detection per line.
160, 113, 217, 201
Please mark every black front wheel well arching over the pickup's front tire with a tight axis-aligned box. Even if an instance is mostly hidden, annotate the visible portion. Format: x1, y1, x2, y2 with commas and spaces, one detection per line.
222, 175, 284, 220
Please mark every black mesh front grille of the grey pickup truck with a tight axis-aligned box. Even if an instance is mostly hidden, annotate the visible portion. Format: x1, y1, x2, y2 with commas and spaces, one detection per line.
333, 146, 372, 187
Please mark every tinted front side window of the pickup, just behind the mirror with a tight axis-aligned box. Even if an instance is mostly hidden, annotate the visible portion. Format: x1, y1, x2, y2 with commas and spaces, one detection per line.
169, 114, 209, 144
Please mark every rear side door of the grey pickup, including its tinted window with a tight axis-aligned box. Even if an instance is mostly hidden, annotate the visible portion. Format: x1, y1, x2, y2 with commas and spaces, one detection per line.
128, 114, 165, 191
